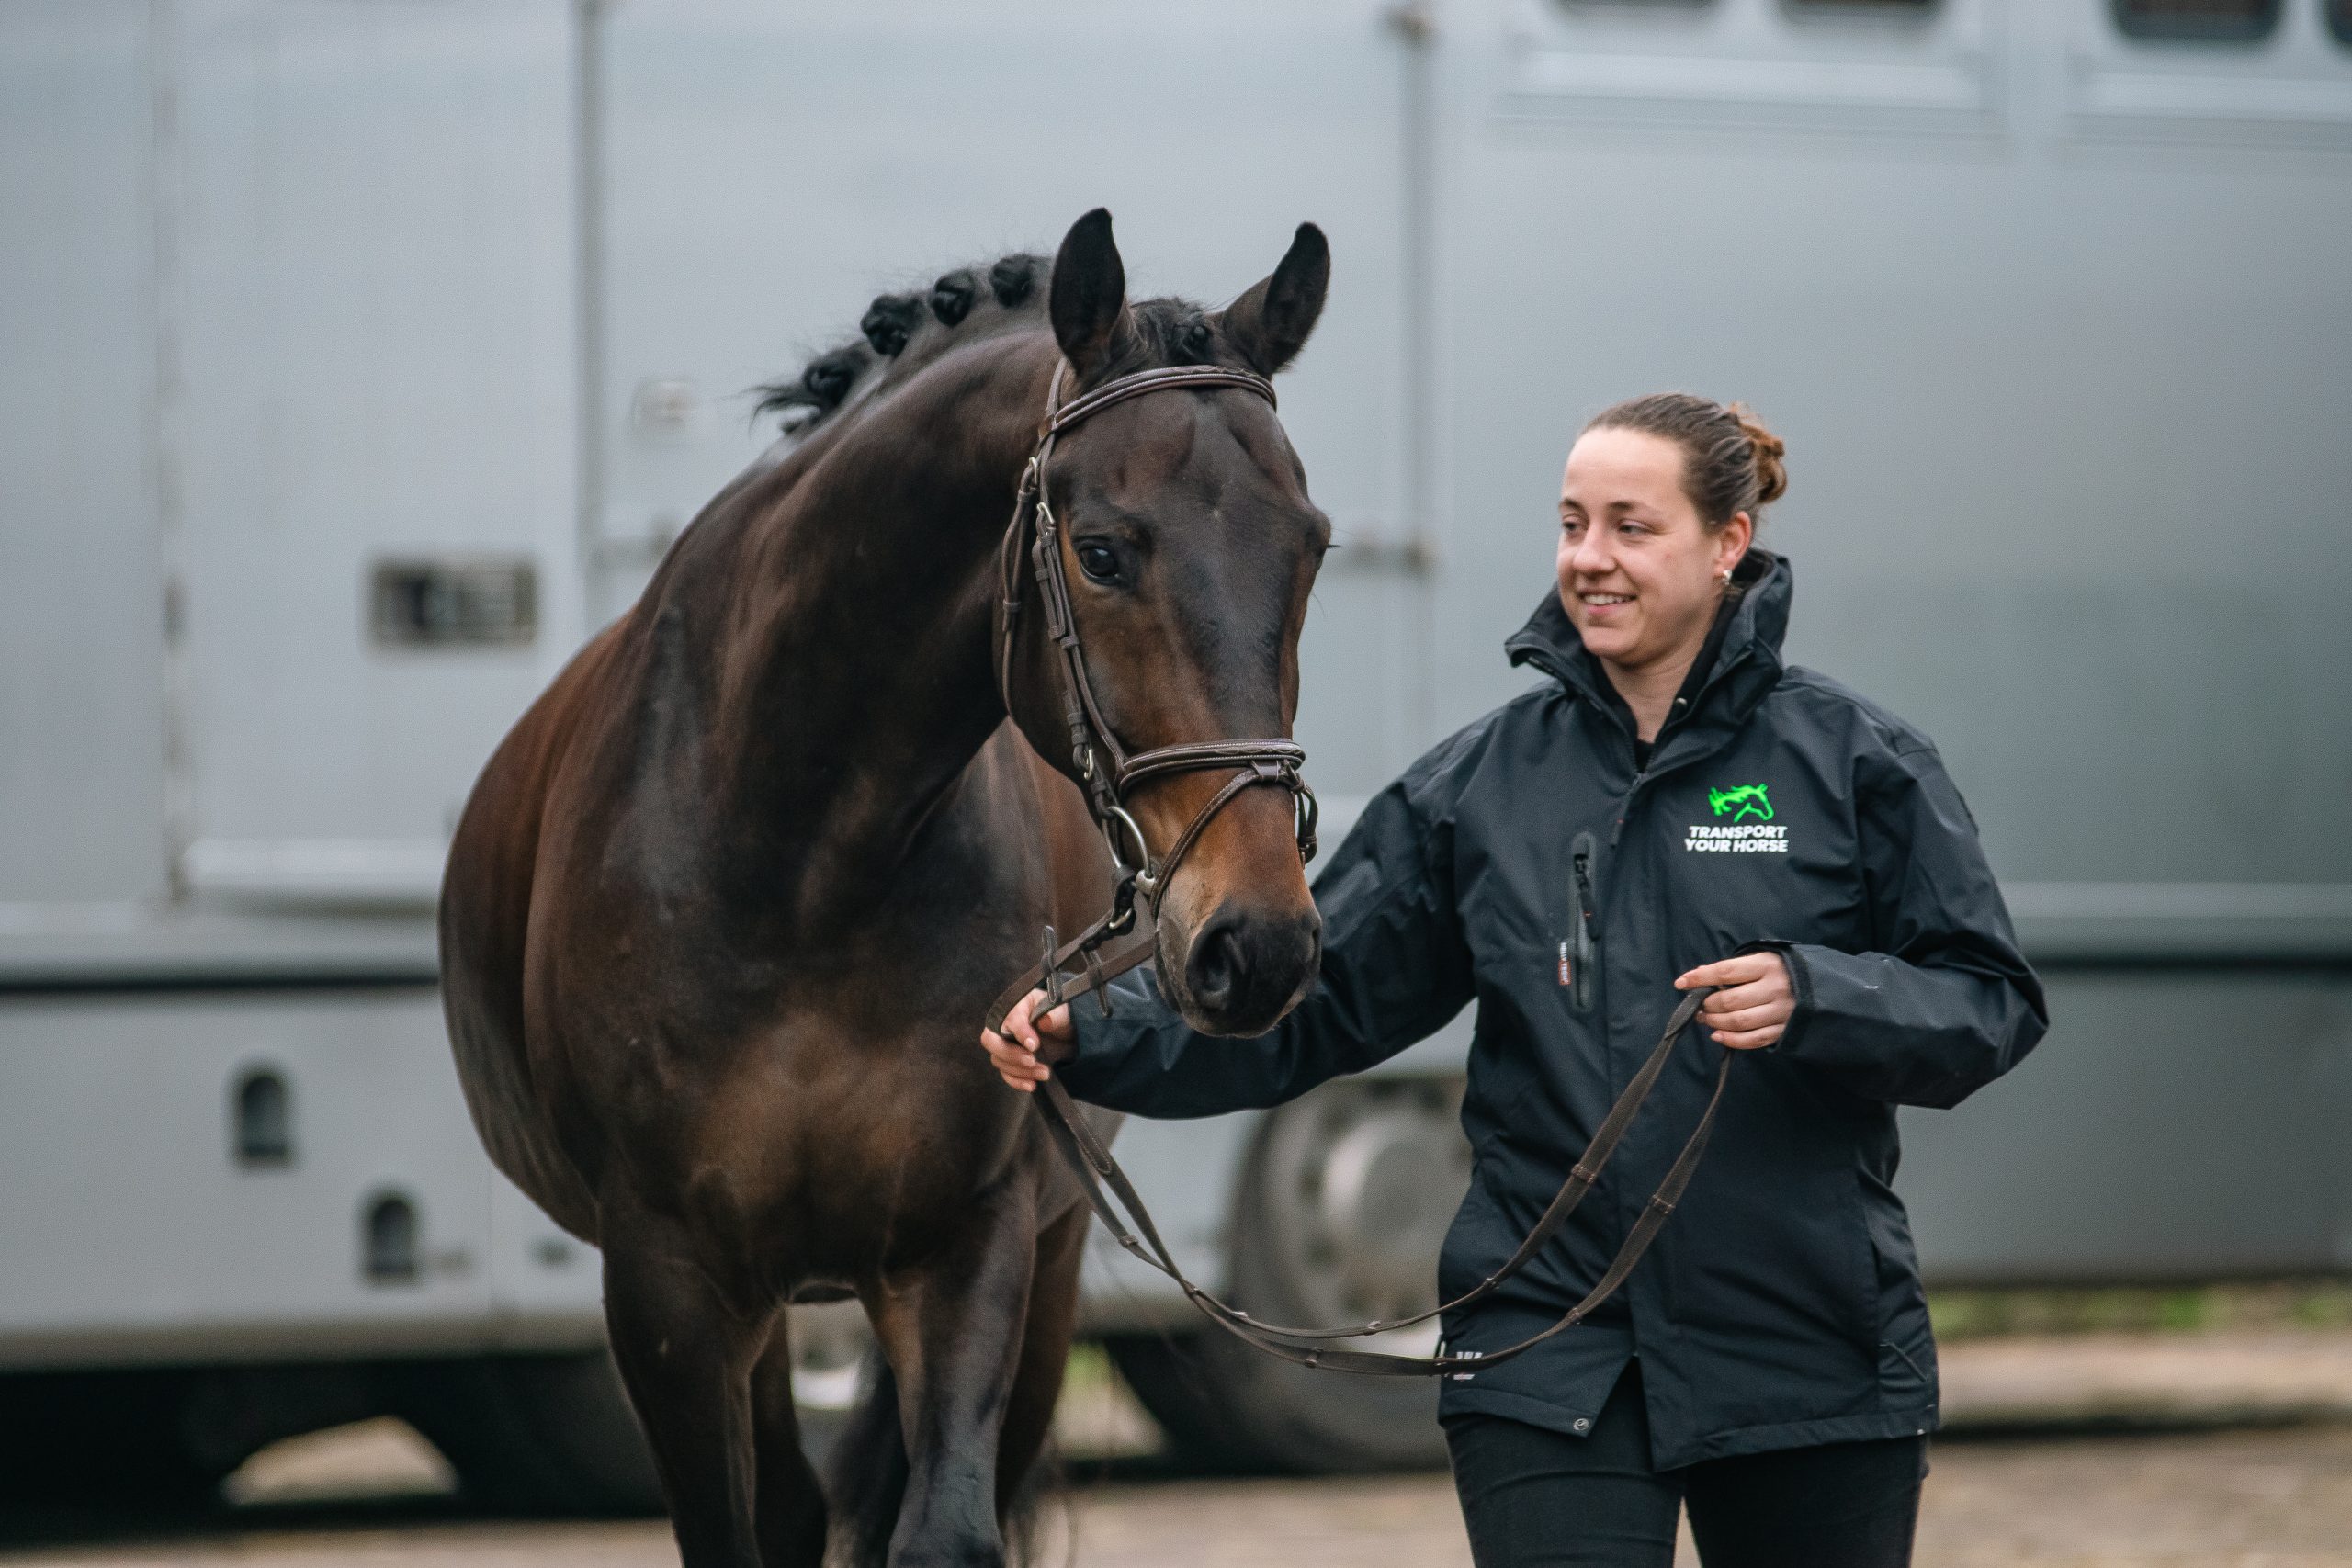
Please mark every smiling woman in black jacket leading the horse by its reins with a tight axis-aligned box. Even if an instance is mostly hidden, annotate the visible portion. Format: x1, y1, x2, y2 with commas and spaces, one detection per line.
981, 376, 2046, 1568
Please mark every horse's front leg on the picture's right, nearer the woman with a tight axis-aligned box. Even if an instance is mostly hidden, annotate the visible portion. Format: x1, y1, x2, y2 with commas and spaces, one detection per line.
868, 1170, 1037, 1568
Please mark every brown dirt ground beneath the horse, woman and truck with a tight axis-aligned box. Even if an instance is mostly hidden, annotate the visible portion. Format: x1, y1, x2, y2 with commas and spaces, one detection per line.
14, 1333, 2352, 1568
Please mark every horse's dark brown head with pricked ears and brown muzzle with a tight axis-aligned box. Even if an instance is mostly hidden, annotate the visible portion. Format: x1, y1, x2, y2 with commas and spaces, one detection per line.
1013, 211, 1331, 1034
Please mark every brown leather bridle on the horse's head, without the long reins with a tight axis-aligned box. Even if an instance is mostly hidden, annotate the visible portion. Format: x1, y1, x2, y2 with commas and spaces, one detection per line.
995, 362, 1317, 1009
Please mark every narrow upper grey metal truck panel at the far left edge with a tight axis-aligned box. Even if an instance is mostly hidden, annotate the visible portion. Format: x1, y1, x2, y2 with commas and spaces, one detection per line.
0, 0, 164, 900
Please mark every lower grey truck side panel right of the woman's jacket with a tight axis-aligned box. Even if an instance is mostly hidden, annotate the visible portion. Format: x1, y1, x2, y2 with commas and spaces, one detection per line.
1895, 968, 2352, 1283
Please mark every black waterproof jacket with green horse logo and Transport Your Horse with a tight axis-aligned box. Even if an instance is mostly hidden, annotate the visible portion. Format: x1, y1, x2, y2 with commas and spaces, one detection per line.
1058, 552, 2046, 1470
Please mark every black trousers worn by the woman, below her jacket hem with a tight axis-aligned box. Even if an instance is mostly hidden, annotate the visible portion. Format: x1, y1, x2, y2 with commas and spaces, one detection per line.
1446, 1361, 1927, 1568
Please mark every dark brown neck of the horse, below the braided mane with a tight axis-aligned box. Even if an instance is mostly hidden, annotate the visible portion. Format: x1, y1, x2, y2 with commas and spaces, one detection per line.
668, 339, 1051, 912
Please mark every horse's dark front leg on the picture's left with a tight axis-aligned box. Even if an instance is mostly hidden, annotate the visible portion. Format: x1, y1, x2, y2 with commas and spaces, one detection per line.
602, 1203, 769, 1568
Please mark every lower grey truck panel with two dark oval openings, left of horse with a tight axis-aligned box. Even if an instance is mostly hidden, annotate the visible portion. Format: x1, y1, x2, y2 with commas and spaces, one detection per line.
0, 989, 597, 1366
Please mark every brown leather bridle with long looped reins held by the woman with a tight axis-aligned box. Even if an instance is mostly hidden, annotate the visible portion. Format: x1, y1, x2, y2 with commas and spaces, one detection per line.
988, 365, 1731, 1378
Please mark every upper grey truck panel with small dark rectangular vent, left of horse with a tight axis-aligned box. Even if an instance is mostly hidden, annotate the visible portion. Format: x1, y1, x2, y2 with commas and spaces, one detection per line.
179, 0, 579, 903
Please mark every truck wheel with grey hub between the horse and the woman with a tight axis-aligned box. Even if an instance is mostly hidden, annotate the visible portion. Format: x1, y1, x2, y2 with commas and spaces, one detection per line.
1108, 1077, 1470, 1474
